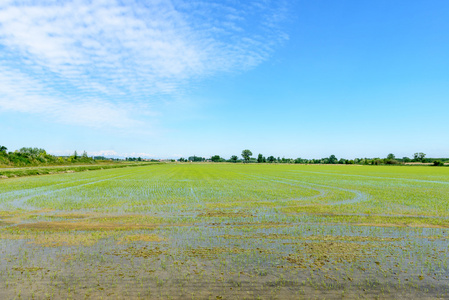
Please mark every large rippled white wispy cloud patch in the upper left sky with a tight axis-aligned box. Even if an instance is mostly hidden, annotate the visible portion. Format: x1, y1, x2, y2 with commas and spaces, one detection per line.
0, 0, 287, 127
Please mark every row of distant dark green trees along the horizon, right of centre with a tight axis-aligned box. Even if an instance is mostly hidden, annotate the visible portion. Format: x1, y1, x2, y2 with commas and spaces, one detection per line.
178, 149, 449, 166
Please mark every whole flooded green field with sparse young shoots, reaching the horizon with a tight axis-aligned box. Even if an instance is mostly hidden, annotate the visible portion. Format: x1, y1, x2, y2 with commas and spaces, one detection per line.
0, 163, 449, 299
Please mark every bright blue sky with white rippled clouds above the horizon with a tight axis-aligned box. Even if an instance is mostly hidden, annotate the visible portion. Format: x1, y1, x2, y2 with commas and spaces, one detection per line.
0, 0, 449, 158
